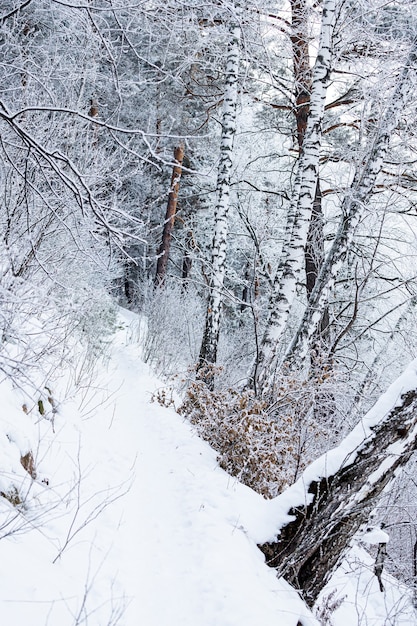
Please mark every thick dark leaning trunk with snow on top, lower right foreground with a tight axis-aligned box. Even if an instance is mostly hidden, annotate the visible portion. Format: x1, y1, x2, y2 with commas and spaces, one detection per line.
260, 361, 417, 605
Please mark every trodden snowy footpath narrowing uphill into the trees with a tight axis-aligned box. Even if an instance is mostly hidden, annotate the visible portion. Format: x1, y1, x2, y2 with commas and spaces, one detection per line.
103, 316, 312, 626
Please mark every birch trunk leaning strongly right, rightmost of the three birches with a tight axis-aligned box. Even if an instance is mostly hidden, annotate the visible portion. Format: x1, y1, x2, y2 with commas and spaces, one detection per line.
285, 43, 417, 369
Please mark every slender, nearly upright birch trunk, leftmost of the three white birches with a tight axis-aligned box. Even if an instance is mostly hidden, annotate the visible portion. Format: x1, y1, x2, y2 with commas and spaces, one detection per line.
197, 9, 241, 388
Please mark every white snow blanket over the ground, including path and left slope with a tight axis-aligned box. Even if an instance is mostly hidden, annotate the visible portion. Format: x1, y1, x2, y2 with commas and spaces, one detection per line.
0, 313, 416, 626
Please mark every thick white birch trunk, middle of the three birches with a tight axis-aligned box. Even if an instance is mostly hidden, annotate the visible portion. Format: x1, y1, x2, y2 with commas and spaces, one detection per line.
250, 0, 336, 393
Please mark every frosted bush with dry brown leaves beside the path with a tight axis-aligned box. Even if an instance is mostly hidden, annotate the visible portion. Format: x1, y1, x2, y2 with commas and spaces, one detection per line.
179, 368, 338, 498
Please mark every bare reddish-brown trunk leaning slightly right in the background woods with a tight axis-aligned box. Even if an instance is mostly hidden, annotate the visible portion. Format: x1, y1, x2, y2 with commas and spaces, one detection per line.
155, 143, 184, 287
